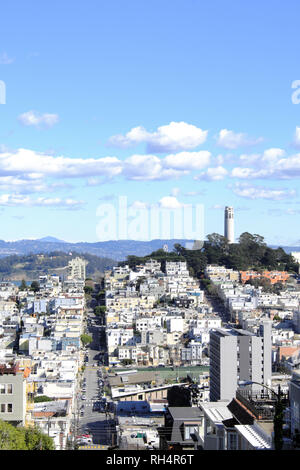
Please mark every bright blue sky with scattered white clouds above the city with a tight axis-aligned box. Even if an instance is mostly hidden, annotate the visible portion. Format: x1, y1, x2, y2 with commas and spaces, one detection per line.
0, 0, 300, 245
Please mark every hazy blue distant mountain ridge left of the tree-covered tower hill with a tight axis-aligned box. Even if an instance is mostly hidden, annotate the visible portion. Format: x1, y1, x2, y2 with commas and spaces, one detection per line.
0, 237, 193, 261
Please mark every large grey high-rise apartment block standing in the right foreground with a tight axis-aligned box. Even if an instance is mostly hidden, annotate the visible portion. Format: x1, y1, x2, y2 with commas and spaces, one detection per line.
210, 320, 272, 401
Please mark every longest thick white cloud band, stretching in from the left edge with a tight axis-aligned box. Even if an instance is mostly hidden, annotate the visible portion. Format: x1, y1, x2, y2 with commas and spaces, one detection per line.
0, 149, 210, 186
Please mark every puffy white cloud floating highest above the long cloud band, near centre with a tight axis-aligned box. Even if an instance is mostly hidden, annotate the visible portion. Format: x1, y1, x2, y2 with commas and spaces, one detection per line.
109, 122, 208, 153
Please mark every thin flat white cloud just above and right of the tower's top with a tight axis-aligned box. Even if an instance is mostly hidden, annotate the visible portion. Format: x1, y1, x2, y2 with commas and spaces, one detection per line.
233, 183, 296, 201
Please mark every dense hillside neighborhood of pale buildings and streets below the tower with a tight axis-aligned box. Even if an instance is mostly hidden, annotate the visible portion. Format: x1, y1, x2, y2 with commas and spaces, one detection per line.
0, 242, 300, 450
